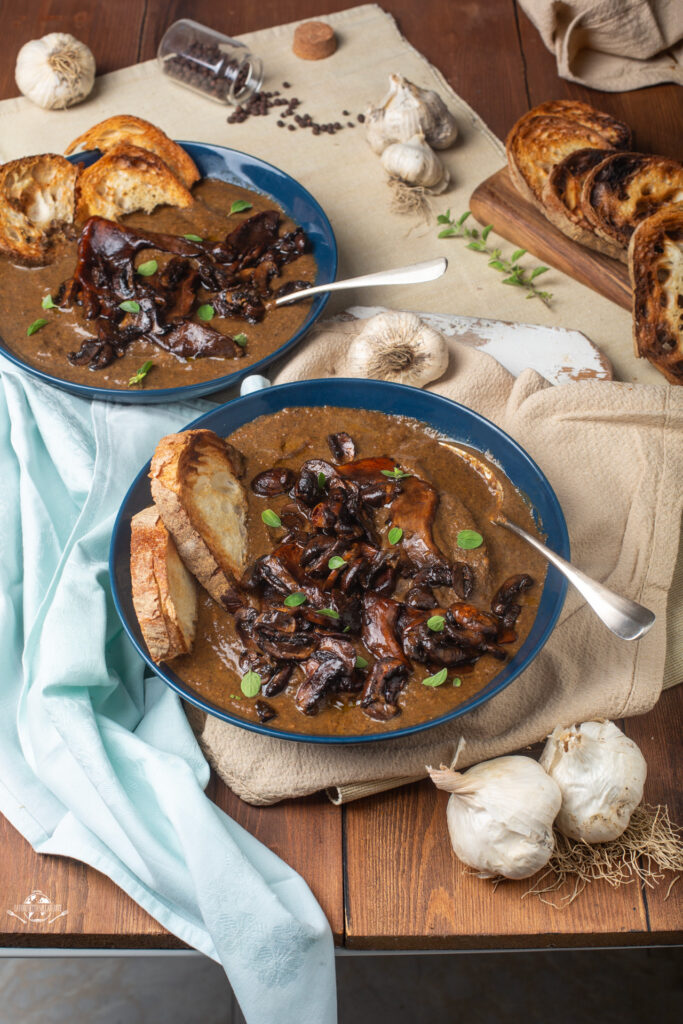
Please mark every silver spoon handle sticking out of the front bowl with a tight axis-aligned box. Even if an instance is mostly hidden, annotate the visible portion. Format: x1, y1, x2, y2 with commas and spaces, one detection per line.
494, 516, 654, 640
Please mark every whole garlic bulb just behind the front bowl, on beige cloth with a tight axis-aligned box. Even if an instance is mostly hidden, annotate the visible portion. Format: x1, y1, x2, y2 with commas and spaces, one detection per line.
345, 312, 449, 387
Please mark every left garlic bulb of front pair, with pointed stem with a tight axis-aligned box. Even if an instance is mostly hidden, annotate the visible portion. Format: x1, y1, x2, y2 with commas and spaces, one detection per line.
427, 755, 562, 879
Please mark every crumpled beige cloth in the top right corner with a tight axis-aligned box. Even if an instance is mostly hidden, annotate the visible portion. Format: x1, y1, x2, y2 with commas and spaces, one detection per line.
519, 0, 683, 92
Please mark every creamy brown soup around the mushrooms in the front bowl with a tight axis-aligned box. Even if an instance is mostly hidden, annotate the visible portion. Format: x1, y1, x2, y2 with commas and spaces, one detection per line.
172, 408, 546, 735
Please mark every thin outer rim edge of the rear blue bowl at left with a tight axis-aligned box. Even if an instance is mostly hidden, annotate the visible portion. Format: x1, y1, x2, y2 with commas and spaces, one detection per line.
0, 139, 339, 404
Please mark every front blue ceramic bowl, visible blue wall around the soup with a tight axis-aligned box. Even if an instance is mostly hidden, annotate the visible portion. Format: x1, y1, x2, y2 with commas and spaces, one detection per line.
110, 378, 569, 743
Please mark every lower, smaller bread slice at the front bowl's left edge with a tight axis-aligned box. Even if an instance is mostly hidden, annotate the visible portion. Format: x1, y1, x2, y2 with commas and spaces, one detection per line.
130, 506, 197, 662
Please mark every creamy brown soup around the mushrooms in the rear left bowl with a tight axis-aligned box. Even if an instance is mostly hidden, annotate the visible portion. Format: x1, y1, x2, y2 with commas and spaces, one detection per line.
0, 179, 315, 390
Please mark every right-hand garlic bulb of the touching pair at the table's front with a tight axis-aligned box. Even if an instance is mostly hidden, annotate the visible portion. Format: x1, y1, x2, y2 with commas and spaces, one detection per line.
541, 722, 647, 843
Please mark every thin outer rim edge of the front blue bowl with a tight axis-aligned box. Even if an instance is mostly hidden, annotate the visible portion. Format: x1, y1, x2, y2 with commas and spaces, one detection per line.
109, 377, 570, 745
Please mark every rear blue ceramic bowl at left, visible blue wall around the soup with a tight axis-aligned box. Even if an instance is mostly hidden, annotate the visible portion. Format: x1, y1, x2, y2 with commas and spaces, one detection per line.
0, 142, 337, 403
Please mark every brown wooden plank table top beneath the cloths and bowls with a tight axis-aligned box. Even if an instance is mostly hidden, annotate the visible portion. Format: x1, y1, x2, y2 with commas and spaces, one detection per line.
0, 0, 683, 949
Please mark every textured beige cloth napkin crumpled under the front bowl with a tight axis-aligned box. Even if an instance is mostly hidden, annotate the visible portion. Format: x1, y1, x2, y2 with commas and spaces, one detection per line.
193, 321, 683, 804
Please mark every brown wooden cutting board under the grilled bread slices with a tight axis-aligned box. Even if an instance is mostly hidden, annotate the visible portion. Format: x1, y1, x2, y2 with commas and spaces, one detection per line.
470, 167, 632, 309
